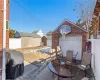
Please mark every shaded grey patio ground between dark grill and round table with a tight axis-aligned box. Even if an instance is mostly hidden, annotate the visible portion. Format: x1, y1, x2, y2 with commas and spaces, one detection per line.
16, 58, 94, 80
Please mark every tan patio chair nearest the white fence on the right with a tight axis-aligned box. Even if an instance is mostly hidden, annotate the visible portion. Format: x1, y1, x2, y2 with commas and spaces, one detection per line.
77, 52, 92, 77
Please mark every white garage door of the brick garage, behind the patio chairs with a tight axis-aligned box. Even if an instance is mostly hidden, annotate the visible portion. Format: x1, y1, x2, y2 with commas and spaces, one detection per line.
59, 36, 82, 60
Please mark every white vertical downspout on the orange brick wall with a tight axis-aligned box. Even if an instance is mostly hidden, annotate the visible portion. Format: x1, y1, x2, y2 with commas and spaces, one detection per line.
2, 0, 6, 80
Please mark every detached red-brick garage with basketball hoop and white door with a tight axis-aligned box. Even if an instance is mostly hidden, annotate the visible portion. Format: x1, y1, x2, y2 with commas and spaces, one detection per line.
52, 20, 87, 60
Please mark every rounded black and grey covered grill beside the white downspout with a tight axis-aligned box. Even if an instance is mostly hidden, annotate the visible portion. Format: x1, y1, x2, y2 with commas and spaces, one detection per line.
6, 50, 24, 79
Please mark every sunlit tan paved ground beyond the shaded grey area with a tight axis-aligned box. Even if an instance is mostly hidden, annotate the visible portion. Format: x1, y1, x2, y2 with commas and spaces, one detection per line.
17, 47, 50, 66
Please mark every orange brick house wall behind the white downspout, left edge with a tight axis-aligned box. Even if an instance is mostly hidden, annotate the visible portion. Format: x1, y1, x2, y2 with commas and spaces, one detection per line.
0, 0, 9, 80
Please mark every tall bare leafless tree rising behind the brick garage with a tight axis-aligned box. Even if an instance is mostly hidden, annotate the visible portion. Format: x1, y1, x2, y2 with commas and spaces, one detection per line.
74, 0, 97, 31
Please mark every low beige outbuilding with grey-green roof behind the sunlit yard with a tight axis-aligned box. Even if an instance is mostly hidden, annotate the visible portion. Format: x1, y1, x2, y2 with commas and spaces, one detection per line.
15, 31, 41, 48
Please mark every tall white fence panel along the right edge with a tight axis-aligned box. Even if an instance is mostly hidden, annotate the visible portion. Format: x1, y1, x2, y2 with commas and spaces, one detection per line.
91, 39, 100, 80
